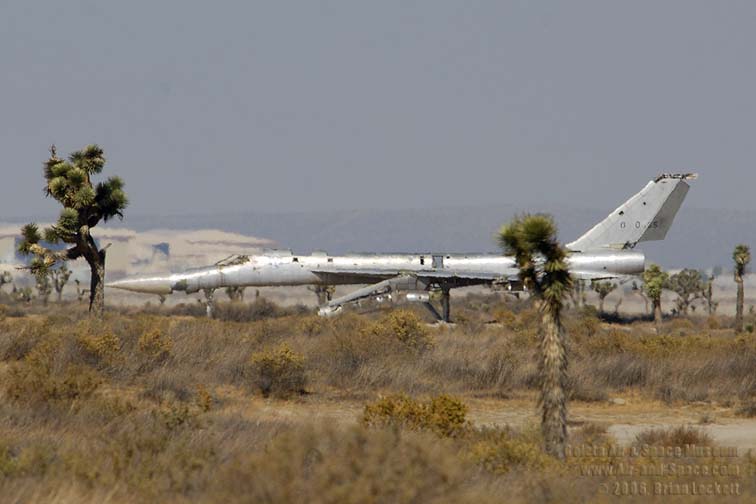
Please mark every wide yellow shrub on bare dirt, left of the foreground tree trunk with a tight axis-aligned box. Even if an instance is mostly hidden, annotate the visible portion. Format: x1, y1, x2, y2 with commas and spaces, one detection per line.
362, 394, 469, 437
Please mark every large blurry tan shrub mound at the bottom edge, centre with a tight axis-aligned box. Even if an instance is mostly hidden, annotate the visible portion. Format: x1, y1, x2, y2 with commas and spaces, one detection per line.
210, 427, 488, 504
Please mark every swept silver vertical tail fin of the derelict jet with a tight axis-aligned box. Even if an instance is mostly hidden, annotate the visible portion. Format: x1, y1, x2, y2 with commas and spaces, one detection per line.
567, 173, 697, 251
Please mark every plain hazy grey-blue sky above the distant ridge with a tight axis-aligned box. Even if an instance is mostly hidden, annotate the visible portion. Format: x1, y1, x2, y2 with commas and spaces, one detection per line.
0, 0, 756, 221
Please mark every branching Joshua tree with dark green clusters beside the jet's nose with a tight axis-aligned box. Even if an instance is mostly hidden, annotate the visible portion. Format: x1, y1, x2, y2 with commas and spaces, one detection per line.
19, 145, 128, 317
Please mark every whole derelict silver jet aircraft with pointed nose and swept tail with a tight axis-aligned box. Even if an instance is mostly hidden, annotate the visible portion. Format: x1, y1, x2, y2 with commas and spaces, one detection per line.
107, 174, 696, 322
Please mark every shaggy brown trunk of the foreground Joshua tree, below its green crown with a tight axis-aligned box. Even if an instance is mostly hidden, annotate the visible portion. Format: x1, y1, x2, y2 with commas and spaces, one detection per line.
540, 309, 567, 460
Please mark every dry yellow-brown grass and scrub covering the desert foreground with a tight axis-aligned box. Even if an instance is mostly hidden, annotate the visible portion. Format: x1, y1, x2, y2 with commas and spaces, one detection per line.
0, 298, 756, 503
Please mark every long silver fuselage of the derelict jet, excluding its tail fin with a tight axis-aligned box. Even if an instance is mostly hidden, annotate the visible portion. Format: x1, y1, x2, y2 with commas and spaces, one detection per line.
108, 250, 645, 294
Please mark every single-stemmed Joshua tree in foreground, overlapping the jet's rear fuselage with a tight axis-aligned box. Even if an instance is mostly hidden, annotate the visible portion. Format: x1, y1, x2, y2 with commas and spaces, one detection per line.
498, 215, 572, 459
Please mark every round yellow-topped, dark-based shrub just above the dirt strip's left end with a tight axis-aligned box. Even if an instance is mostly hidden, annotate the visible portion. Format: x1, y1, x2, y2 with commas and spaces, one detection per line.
250, 343, 306, 397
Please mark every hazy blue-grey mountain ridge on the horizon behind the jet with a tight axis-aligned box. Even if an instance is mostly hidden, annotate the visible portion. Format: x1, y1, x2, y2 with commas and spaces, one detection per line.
109, 205, 756, 268
